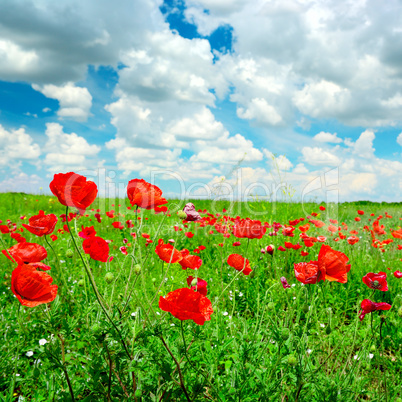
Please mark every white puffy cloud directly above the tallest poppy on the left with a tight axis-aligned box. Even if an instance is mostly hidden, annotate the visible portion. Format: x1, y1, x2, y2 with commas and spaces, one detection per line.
44, 123, 100, 172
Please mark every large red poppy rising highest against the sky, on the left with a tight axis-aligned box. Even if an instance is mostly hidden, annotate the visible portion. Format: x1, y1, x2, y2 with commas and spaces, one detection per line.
49, 172, 98, 214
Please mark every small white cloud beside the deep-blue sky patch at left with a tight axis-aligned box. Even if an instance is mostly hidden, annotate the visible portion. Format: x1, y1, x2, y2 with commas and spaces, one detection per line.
32, 82, 92, 122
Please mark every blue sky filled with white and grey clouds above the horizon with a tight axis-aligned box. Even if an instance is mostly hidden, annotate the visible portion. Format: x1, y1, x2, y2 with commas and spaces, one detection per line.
0, 0, 402, 201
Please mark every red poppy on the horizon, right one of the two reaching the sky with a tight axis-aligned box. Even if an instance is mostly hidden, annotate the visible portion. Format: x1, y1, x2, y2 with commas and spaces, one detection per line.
127, 179, 167, 209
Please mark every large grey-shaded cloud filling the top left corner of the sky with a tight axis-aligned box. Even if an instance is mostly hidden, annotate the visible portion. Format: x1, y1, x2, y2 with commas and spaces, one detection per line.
0, 0, 166, 85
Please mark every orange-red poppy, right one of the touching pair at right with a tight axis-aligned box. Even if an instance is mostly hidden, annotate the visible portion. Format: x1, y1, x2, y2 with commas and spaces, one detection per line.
318, 245, 351, 283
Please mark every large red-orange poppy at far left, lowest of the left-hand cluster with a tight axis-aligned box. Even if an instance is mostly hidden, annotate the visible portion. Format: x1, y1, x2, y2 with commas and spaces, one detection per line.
11, 264, 58, 307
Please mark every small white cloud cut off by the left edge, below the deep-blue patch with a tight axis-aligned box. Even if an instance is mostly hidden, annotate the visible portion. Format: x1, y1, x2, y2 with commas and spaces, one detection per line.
0, 124, 41, 167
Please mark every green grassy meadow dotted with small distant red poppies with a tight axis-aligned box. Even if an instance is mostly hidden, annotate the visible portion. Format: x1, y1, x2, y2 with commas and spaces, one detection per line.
0, 189, 402, 402
